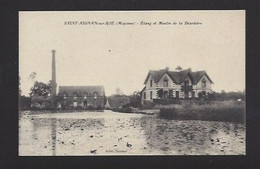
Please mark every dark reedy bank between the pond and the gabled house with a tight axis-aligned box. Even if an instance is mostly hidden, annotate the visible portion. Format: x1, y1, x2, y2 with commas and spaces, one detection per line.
159, 101, 245, 123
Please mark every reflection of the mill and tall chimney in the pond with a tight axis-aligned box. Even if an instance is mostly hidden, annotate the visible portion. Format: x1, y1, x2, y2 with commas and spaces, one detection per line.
31, 118, 104, 156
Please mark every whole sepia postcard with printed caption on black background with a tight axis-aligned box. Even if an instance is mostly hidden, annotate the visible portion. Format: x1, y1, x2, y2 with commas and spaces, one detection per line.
18, 10, 246, 156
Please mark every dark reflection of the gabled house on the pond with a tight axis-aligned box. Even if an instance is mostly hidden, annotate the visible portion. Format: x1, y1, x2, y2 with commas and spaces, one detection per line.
141, 116, 219, 153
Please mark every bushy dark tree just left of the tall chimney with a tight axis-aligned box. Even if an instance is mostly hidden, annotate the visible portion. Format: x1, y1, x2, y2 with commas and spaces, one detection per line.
30, 81, 52, 96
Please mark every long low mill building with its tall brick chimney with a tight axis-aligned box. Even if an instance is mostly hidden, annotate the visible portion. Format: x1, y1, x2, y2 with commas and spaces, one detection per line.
31, 50, 105, 109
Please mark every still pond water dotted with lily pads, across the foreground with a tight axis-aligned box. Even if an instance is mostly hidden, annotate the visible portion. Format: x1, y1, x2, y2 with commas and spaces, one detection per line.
19, 111, 245, 156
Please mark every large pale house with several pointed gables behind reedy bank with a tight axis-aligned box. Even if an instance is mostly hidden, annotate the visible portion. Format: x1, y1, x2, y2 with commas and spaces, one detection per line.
140, 67, 213, 103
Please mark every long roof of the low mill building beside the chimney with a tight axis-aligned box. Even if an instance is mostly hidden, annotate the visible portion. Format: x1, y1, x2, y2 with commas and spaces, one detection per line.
58, 86, 105, 96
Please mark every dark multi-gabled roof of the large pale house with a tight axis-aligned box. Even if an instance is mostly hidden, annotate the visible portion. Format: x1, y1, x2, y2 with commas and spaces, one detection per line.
144, 69, 213, 84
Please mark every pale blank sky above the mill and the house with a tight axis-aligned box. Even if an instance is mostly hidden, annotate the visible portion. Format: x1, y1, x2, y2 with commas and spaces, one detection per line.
19, 10, 245, 96
